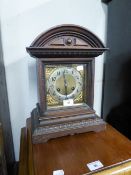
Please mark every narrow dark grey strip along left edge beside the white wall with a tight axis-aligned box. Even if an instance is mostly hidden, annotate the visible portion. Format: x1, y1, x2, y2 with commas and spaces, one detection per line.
0, 21, 15, 171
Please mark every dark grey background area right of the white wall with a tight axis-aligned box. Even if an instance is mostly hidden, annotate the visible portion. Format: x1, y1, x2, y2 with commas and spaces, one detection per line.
102, 0, 131, 138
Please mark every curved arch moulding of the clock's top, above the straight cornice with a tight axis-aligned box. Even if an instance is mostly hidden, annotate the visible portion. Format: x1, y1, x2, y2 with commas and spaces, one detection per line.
31, 25, 104, 48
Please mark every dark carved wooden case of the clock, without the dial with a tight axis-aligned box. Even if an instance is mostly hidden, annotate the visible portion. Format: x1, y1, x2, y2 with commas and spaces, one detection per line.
26, 25, 107, 143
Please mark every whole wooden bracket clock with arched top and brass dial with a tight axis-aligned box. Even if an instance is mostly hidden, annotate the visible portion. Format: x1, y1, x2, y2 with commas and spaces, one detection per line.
26, 25, 107, 143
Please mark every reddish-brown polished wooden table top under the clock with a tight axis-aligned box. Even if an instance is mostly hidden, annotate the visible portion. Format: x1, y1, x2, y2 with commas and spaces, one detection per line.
19, 119, 131, 175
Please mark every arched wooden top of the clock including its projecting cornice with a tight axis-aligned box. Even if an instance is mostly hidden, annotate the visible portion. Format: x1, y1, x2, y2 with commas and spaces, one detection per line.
26, 25, 107, 61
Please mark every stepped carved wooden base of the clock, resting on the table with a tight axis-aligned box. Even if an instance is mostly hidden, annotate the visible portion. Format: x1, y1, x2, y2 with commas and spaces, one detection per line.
31, 104, 106, 144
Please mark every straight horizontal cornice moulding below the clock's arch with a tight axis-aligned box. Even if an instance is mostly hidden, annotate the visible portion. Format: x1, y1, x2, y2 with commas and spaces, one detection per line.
27, 46, 107, 59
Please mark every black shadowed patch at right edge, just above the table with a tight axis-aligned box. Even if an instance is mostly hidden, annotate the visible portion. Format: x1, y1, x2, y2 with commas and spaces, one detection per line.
107, 58, 131, 139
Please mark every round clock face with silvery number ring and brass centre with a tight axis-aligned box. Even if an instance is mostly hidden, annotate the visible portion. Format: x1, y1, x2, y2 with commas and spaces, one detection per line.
48, 67, 83, 102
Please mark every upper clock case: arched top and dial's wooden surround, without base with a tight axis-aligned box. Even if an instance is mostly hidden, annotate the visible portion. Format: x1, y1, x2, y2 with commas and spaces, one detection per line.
26, 25, 107, 113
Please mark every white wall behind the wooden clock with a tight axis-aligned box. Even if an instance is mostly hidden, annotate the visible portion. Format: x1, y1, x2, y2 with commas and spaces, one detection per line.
1, 0, 107, 160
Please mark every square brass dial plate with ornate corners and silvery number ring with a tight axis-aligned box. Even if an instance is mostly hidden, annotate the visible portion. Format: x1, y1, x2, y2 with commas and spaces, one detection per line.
46, 64, 84, 107
